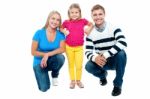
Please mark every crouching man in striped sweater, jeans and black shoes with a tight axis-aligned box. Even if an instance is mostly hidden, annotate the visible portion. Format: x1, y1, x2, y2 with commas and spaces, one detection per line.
85, 5, 127, 96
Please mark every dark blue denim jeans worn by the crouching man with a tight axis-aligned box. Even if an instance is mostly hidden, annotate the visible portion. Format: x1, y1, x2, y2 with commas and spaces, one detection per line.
85, 50, 127, 88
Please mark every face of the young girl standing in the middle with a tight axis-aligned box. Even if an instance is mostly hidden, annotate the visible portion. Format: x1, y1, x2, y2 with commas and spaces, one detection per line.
69, 8, 81, 20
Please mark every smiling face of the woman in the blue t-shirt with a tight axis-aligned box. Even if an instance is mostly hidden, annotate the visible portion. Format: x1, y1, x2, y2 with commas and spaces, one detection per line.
49, 13, 61, 29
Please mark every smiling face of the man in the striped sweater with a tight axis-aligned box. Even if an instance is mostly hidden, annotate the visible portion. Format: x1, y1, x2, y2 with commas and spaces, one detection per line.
92, 9, 105, 26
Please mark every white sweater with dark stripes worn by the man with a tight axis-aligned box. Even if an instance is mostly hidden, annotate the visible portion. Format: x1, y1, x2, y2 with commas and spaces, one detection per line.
85, 23, 127, 61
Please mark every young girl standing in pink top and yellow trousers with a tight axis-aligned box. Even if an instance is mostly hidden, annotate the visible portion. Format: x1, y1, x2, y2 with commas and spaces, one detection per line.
61, 4, 93, 89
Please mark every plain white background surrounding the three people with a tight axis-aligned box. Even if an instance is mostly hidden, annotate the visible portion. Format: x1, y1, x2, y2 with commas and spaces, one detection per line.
0, 0, 150, 99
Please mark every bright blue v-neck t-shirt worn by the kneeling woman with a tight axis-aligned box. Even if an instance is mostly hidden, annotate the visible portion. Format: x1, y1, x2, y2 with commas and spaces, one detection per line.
32, 29, 65, 66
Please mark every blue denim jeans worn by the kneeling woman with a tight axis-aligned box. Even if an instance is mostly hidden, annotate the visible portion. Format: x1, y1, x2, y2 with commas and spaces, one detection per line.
33, 54, 65, 92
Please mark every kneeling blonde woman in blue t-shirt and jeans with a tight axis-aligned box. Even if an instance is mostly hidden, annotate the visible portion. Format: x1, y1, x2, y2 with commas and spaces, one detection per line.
31, 11, 65, 92
